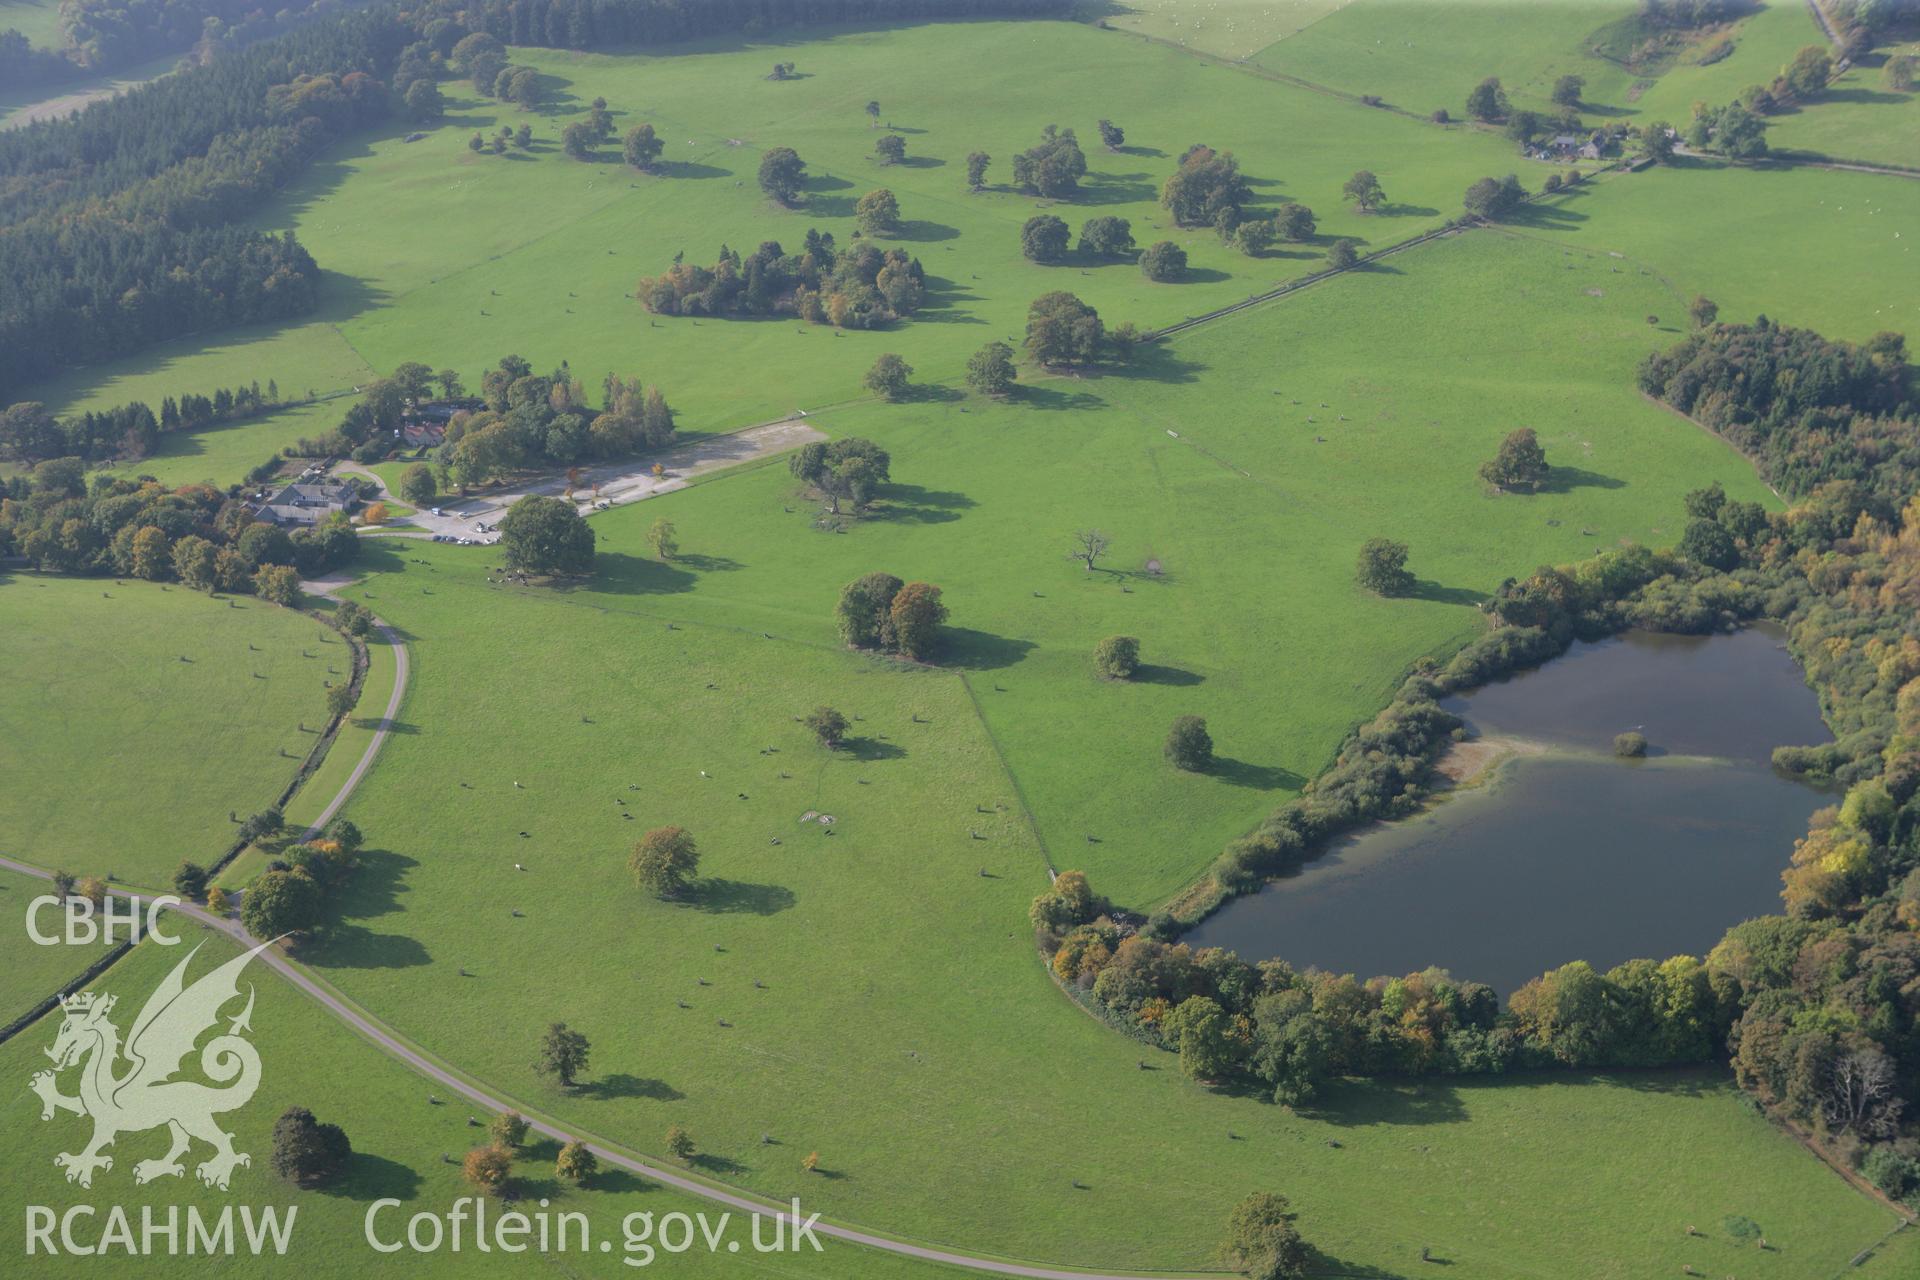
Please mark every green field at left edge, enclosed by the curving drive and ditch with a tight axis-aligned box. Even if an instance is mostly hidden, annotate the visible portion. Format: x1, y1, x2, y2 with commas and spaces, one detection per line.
0, 574, 346, 887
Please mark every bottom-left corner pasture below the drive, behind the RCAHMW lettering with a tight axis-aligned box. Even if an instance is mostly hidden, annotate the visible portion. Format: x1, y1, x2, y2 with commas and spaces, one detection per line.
0, 923, 952, 1280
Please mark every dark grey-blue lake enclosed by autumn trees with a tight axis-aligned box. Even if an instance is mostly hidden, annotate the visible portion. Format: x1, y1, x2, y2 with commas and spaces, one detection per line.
1187, 628, 1834, 992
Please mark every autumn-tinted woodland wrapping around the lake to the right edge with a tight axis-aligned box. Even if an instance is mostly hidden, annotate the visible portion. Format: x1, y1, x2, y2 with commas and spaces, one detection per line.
1033, 319, 1920, 1197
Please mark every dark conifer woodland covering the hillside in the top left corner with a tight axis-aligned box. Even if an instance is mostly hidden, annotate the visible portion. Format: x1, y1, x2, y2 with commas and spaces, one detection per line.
0, 0, 1068, 405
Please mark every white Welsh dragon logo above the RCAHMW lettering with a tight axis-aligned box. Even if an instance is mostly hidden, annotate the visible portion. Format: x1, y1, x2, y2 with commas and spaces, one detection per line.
31, 942, 271, 1190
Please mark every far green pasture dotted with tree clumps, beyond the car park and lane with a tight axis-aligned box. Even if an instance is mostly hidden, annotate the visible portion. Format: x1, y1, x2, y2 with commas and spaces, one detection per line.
261, 23, 1507, 432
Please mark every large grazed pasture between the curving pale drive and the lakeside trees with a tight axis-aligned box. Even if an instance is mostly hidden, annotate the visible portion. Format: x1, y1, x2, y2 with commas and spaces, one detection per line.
280, 525, 1887, 1276
